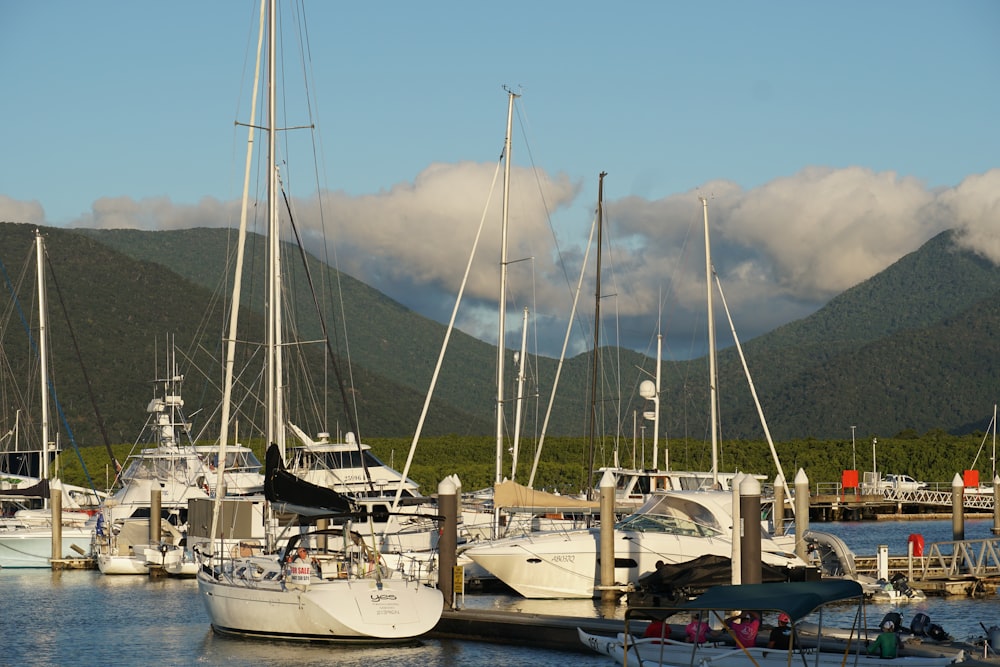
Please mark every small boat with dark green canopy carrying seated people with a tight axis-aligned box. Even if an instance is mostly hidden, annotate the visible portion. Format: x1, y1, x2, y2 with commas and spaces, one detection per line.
578, 580, 965, 667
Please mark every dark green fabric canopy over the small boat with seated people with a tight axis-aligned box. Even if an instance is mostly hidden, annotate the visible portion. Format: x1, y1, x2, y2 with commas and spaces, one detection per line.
625, 579, 864, 622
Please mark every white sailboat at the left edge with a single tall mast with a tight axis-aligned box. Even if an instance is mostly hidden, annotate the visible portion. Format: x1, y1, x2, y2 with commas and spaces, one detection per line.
0, 230, 98, 568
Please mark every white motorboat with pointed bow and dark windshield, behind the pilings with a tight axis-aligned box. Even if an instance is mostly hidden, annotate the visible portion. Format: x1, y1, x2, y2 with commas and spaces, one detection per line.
463, 491, 808, 598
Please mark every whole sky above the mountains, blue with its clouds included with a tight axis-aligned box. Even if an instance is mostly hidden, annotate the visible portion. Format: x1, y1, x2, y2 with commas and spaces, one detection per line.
0, 0, 1000, 357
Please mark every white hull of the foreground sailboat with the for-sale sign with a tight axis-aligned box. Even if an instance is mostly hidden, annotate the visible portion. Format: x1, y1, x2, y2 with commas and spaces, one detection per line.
198, 572, 444, 642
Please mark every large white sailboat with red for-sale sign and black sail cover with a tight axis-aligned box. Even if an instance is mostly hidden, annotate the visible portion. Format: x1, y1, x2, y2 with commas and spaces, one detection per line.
197, 0, 444, 643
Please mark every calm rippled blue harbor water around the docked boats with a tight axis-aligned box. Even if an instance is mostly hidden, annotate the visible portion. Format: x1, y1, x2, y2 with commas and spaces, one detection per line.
0, 519, 1000, 667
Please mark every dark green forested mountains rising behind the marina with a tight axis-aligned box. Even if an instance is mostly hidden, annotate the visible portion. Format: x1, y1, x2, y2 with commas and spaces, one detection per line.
0, 223, 1000, 452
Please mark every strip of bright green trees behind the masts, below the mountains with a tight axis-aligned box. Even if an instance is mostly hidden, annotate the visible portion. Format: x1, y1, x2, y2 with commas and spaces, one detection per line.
59, 430, 995, 494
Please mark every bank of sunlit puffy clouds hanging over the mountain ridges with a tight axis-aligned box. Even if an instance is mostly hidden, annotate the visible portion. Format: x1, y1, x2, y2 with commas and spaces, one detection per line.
0, 163, 1000, 358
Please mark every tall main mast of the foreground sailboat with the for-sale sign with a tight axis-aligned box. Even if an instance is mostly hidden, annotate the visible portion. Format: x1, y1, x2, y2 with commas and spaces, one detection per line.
267, 0, 285, 458
